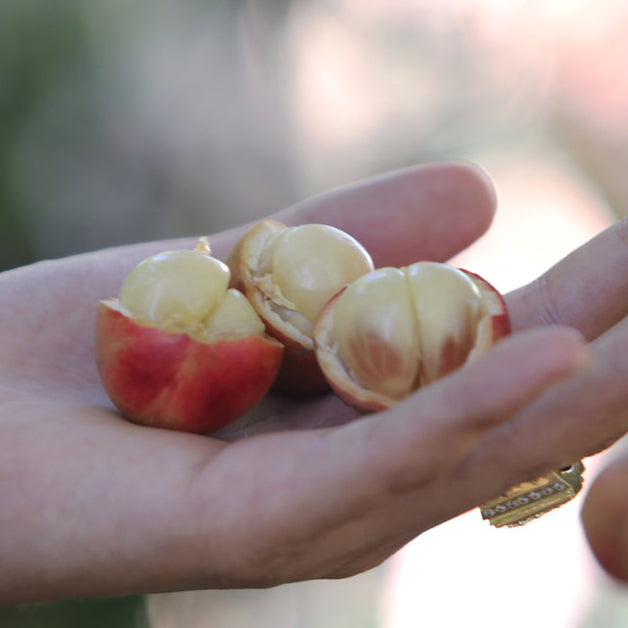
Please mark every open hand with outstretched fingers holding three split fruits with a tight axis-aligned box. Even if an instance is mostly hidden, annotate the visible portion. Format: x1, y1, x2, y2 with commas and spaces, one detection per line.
0, 164, 628, 604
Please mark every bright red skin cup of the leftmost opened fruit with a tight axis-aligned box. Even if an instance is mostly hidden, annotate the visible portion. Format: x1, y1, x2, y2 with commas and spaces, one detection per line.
96, 300, 283, 434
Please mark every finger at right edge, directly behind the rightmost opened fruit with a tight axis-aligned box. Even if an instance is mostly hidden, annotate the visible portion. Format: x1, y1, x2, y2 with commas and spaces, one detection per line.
506, 219, 628, 339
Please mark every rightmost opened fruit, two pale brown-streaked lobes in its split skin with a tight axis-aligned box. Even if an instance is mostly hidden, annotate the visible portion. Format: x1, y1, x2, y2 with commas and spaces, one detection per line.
314, 262, 510, 411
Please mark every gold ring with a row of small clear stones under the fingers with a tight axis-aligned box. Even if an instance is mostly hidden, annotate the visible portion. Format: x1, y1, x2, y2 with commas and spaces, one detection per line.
480, 461, 584, 528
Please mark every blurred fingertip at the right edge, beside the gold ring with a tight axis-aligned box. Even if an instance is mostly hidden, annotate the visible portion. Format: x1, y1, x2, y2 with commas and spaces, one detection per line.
581, 453, 628, 581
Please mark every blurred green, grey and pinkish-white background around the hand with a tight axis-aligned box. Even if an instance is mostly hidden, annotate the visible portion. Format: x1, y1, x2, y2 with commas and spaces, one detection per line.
0, 0, 628, 628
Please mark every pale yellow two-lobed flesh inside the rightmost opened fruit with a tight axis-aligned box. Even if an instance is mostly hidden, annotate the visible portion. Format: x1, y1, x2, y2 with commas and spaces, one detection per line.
333, 262, 485, 399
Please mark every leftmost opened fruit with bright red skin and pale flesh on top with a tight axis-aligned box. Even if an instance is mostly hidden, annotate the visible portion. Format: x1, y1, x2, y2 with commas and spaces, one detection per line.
96, 239, 283, 433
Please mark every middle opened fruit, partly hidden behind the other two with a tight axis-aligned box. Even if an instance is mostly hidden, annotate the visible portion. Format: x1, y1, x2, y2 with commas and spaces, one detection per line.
228, 220, 373, 393
